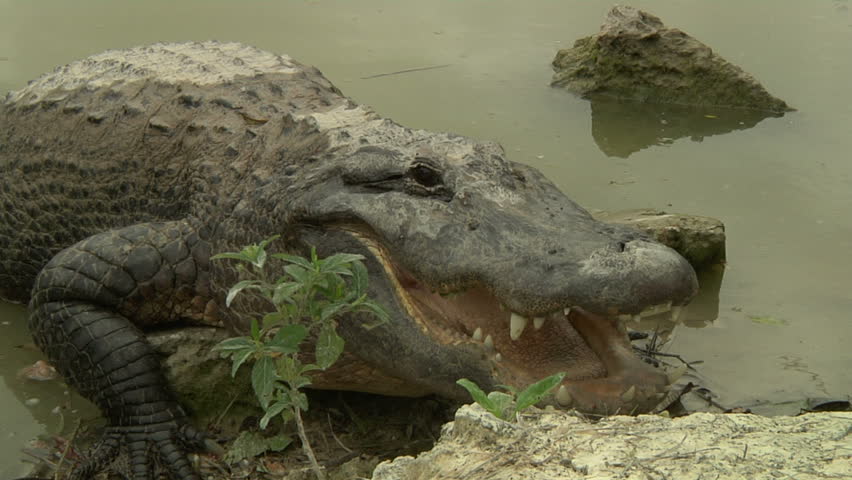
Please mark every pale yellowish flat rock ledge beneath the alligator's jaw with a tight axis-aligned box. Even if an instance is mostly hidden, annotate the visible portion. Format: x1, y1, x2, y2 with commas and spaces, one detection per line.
373, 405, 852, 480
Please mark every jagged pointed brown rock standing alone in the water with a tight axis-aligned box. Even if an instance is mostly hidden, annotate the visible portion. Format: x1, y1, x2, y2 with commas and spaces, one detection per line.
551, 6, 793, 113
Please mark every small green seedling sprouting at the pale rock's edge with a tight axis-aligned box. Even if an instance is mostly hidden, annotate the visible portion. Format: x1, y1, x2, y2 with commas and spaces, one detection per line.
456, 372, 565, 420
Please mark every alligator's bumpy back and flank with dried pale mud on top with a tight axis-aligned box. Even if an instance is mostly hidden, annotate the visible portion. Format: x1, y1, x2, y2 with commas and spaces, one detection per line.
0, 42, 348, 302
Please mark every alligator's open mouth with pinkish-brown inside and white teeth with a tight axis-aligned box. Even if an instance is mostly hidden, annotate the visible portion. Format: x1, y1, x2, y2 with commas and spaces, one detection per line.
349, 227, 683, 414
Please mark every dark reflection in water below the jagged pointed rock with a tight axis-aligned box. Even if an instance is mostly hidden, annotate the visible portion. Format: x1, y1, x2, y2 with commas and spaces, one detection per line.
591, 99, 782, 158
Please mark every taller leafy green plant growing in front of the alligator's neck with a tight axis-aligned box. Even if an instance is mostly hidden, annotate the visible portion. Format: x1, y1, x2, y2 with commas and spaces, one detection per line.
212, 236, 388, 478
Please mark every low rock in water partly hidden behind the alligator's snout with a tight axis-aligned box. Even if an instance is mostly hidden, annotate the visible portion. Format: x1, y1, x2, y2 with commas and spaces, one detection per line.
594, 209, 725, 270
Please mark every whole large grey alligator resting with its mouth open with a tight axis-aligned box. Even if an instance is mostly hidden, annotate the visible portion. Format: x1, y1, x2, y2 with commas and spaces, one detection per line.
0, 42, 697, 480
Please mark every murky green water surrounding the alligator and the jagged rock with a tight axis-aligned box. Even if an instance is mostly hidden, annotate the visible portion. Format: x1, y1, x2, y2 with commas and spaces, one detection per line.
0, 0, 852, 476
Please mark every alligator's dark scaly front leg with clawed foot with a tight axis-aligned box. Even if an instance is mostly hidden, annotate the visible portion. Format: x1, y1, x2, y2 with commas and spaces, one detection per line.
30, 221, 218, 480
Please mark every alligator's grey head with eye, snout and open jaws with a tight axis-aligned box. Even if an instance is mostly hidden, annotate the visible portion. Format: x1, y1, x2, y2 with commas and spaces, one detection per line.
276, 105, 697, 413
